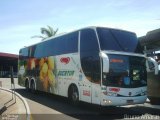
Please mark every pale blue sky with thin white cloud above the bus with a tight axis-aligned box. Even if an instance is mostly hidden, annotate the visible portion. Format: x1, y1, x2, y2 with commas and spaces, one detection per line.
0, 0, 160, 54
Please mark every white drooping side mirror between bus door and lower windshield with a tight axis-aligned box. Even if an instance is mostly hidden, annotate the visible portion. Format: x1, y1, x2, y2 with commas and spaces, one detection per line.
100, 52, 109, 73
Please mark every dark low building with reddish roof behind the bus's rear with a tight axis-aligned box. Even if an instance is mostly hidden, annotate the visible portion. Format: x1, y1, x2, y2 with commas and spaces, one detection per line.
0, 52, 18, 78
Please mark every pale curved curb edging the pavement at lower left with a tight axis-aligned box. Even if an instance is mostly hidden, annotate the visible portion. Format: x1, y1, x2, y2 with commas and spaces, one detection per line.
0, 87, 31, 120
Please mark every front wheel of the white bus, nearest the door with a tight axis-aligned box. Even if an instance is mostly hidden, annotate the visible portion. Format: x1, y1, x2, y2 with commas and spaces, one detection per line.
68, 85, 79, 105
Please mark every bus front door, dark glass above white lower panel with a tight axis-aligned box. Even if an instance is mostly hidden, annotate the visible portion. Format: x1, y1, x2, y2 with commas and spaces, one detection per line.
80, 55, 101, 104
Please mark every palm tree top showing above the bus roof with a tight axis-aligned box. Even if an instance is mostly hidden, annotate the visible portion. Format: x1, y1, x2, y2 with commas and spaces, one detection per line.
31, 25, 58, 41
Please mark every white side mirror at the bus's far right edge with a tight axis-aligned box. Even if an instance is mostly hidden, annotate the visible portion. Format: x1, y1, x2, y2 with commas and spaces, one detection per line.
147, 57, 158, 75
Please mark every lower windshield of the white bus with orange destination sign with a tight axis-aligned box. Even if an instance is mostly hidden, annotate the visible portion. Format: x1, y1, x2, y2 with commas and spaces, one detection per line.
103, 54, 147, 88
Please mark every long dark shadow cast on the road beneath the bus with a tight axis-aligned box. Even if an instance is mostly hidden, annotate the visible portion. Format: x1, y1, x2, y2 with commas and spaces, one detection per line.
16, 89, 160, 120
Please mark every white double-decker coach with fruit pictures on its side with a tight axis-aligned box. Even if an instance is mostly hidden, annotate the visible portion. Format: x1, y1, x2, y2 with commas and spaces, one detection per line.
18, 27, 147, 106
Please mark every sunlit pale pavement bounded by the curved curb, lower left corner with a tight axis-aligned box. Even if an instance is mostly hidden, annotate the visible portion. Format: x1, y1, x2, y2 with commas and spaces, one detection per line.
0, 81, 31, 120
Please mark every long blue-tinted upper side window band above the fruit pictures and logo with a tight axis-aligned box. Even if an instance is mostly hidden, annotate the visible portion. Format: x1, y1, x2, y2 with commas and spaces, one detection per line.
29, 32, 78, 58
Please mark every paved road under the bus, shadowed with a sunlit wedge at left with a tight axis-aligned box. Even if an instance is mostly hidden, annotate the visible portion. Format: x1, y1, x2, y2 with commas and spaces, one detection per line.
1, 78, 160, 120
